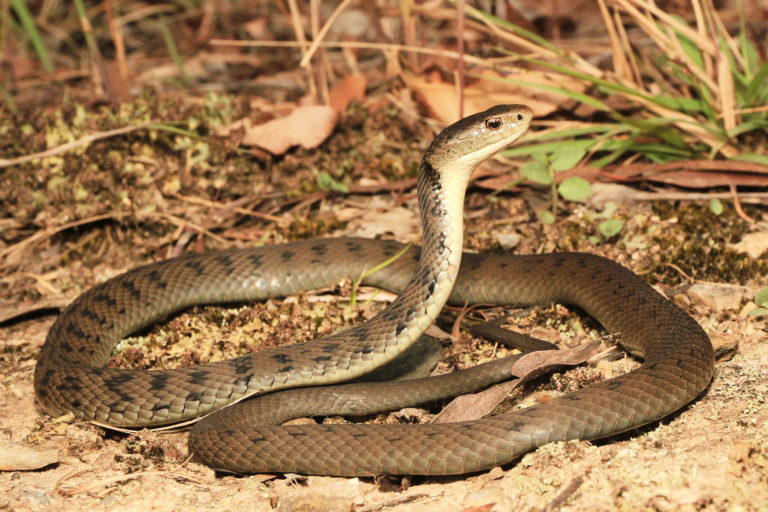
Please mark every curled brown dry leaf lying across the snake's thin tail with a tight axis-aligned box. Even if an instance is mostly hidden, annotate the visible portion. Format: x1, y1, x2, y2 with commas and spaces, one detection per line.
432, 341, 600, 423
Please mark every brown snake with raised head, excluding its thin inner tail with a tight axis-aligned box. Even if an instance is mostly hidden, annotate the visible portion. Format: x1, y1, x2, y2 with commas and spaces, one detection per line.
34, 105, 714, 476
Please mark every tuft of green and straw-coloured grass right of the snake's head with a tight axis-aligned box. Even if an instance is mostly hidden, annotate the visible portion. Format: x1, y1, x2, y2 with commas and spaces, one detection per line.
474, 0, 768, 167
